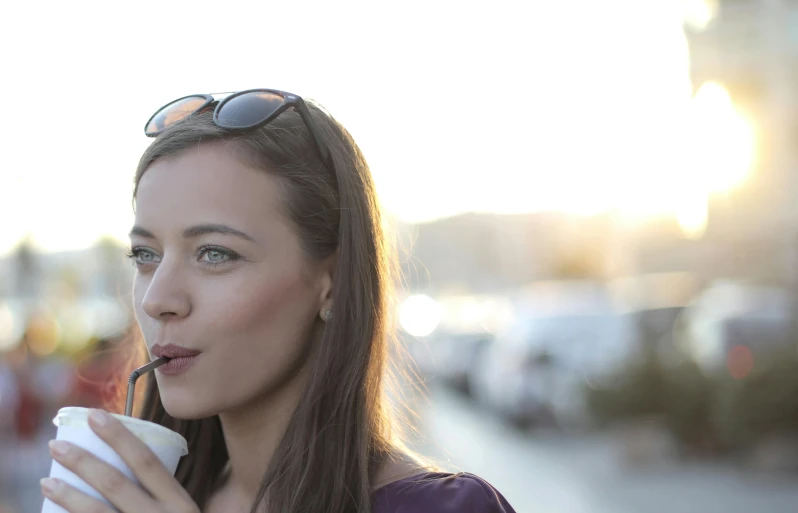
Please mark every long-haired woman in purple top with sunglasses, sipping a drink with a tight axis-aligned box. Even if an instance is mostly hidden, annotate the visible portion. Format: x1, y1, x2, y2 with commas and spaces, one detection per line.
43, 90, 512, 513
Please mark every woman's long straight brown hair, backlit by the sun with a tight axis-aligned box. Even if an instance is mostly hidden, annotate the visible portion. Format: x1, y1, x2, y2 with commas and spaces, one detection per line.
134, 103, 418, 513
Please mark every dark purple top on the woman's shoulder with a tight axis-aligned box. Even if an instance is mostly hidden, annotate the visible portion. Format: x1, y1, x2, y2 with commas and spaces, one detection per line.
373, 472, 515, 513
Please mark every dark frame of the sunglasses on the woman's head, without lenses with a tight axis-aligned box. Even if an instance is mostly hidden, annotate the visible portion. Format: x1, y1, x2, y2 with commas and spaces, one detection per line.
144, 89, 337, 176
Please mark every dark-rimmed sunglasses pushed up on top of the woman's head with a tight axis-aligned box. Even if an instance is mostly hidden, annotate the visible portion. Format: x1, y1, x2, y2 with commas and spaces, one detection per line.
144, 89, 335, 173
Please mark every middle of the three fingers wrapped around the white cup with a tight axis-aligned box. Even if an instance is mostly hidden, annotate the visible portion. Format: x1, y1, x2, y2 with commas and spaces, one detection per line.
50, 440, 156, 512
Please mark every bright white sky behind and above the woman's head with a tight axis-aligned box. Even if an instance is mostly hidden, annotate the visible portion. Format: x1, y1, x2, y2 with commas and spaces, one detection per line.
0, 0, 740, 254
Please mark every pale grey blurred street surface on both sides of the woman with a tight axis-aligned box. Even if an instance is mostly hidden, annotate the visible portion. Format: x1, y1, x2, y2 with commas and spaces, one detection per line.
0, 386, 798, 513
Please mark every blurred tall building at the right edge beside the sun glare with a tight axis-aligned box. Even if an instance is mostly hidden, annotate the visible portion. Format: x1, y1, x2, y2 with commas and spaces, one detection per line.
685, 0, 798, 283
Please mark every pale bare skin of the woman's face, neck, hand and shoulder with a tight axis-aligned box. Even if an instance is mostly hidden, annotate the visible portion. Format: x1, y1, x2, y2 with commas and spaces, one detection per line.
42, 143, 418, 513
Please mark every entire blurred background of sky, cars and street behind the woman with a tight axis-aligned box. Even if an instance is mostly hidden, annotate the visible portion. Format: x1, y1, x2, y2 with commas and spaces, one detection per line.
0, 0, 798, 513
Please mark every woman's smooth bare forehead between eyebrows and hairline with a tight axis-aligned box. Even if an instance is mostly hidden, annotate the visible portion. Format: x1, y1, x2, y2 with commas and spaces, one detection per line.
136, 144, 281, 231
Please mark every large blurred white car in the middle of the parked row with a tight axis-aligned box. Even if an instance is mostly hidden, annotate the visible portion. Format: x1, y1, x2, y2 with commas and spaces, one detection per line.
473, 281, 635, 427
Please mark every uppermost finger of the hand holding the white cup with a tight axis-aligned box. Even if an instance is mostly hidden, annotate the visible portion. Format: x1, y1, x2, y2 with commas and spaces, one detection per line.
89, 410, 193, 505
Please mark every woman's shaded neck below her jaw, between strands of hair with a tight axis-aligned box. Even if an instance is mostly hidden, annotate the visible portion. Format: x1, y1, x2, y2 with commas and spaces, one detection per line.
219, 366, 308, 507
